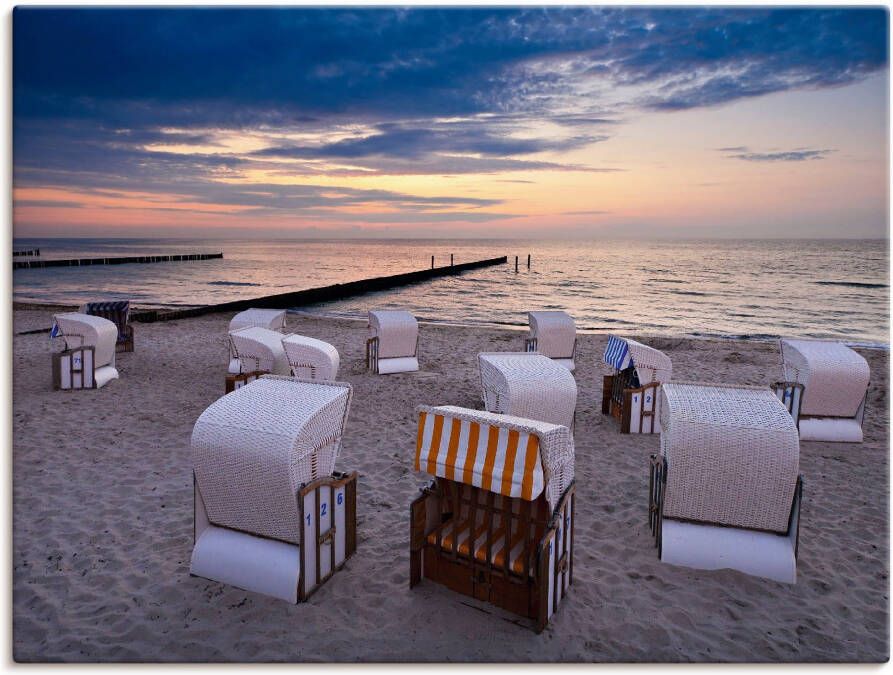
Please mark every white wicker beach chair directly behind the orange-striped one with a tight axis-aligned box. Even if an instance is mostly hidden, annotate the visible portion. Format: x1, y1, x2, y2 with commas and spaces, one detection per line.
478, 352, 577, 431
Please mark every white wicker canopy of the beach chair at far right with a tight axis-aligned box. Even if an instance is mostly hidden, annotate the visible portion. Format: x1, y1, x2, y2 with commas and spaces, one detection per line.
780, 340, 870, 417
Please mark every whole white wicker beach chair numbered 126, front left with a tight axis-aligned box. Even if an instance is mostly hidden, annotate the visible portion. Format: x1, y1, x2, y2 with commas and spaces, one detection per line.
189, 375, 357, 603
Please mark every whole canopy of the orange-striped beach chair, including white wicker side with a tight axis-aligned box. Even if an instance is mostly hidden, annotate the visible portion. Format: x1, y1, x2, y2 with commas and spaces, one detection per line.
415, 406, 574, 509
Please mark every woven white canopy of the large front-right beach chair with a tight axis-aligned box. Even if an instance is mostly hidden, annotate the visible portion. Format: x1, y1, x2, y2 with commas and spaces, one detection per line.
660, 383, 800, 532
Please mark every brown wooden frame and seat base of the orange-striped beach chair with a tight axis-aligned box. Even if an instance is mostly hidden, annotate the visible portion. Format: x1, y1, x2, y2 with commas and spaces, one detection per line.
409, 478, 575, 633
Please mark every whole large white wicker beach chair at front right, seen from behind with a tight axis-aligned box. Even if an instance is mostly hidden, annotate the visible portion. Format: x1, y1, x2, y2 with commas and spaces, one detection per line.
649, 382, 803, 584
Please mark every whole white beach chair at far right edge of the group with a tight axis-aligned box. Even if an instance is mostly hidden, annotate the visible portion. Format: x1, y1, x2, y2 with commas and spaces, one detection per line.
773, 340, 870, 443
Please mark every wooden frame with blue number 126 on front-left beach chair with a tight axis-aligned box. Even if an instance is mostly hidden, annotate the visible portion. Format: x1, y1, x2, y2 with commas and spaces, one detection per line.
190, 471, 359, 602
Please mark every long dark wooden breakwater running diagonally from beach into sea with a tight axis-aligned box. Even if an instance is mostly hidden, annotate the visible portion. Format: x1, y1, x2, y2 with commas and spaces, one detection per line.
131, 256, 508, 323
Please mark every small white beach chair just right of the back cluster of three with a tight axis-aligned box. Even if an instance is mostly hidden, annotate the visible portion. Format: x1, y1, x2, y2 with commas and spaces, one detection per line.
366, 309, 419, 375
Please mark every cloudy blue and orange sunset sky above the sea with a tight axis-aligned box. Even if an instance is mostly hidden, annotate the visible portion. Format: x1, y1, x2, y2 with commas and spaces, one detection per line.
13, 7, 890, 239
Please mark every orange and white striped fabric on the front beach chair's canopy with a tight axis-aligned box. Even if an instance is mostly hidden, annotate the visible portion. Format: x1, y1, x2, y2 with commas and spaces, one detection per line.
415, 410, 545, 501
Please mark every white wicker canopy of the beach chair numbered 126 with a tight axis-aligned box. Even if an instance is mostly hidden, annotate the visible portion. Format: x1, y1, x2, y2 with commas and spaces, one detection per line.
192, 375, 351, 544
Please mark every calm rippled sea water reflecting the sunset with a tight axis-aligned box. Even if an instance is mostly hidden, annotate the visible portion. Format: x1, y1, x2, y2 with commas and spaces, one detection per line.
13, 239, 890, 345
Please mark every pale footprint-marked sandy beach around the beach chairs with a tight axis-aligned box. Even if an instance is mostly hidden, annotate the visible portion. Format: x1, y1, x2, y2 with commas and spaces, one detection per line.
12, 309, 889, 662
